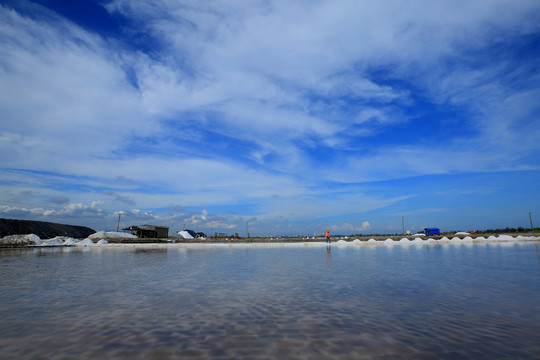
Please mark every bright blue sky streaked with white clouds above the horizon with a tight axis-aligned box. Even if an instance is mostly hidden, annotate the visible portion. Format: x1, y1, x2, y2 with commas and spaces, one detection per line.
0, 0, 540, 235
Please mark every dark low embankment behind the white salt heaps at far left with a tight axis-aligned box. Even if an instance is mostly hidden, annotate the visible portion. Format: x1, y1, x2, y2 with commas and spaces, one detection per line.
0, 218, 96, 239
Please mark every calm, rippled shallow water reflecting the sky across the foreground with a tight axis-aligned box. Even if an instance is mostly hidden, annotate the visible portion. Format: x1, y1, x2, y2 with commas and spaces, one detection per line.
0, 243, 540, 359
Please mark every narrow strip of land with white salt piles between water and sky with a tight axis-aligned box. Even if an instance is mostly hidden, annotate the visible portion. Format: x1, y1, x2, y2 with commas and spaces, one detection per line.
0, 214, 540, 248
